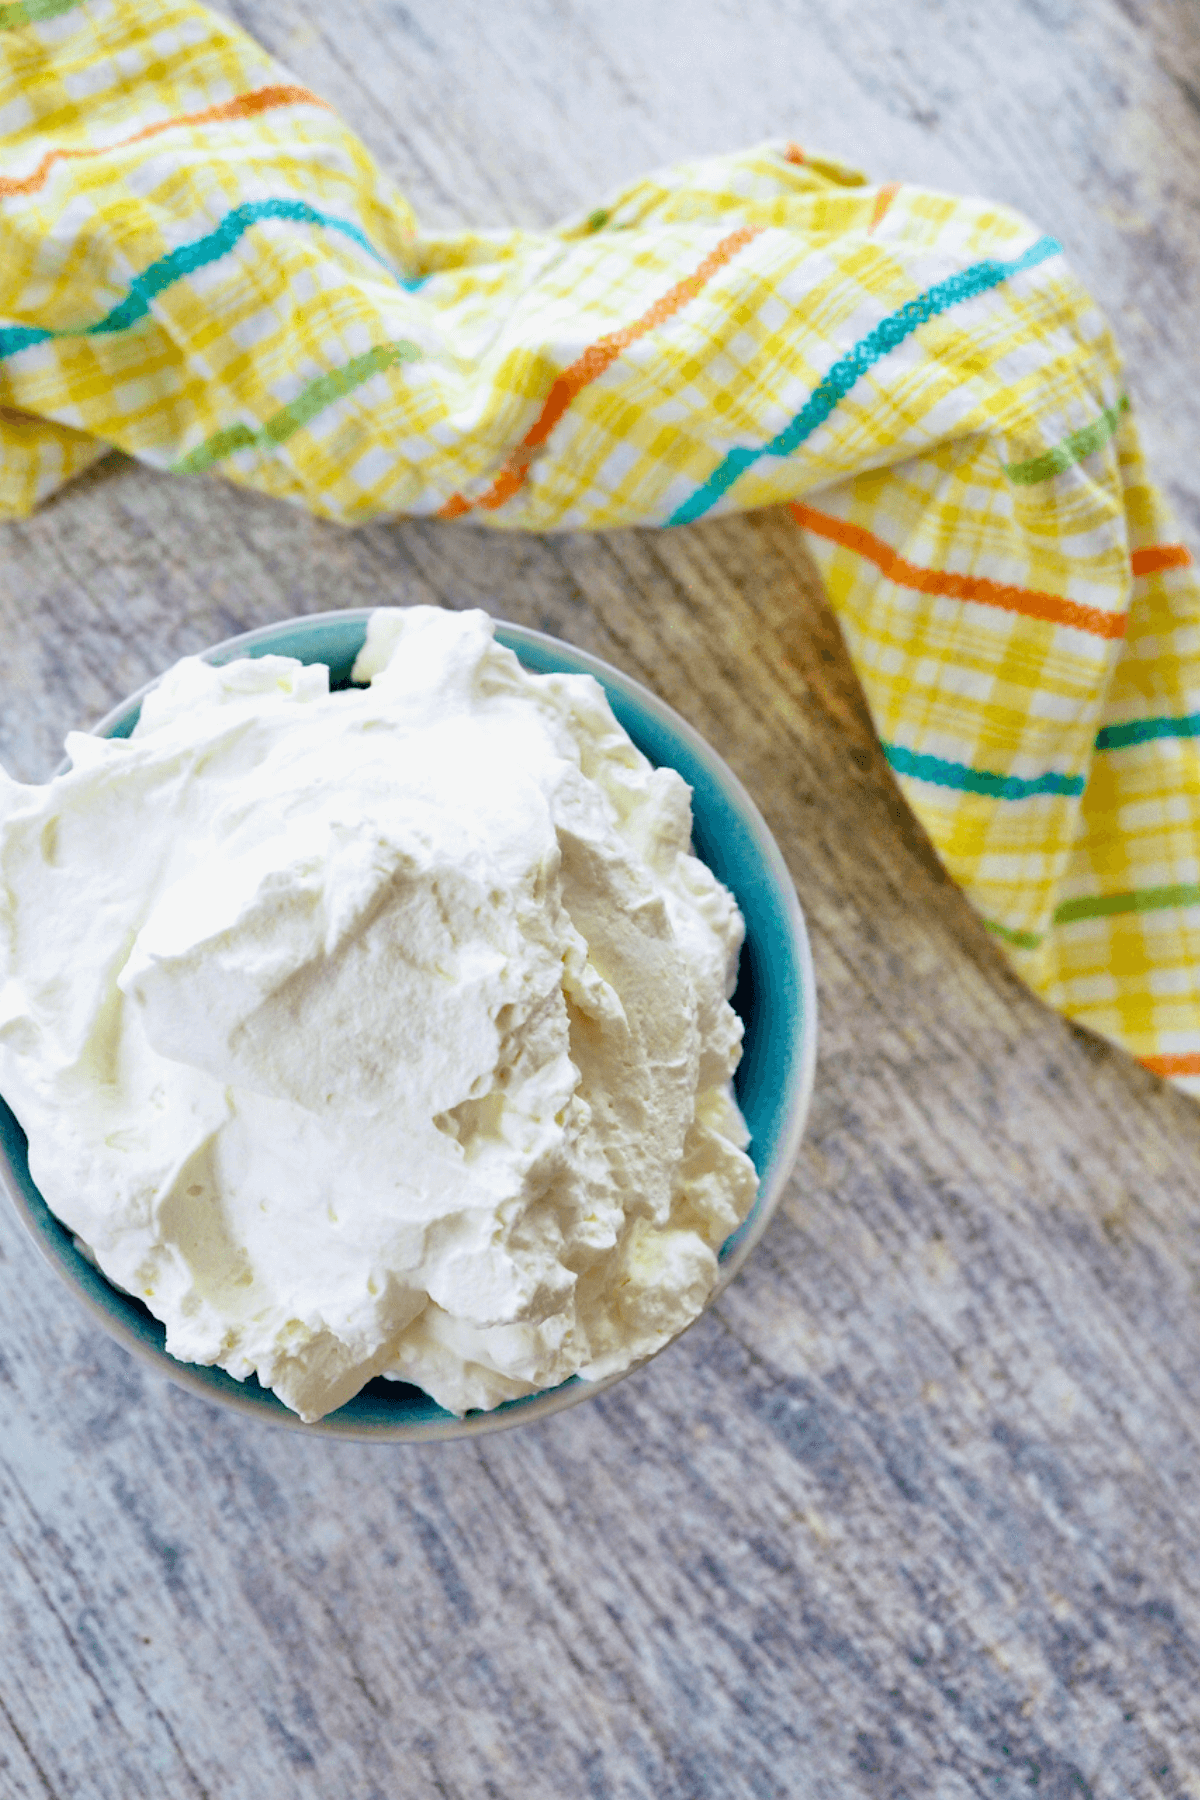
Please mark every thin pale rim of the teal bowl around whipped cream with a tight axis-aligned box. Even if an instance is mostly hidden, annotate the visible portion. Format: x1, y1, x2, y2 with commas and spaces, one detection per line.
0, 607, 817, 1444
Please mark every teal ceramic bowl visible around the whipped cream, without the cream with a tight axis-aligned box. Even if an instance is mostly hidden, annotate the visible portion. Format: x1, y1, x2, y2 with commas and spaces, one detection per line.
0, 608, 817, 1442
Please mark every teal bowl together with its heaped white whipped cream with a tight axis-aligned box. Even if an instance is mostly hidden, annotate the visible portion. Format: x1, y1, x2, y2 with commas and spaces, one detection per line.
0, 607, 817, 1440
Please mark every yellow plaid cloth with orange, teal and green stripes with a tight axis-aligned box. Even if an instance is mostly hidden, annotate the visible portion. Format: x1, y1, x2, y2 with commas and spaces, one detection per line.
0, 0, 1200, 1093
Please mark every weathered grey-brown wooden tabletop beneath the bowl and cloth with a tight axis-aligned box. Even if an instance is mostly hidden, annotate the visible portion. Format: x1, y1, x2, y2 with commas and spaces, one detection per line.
0, 0, 1200, 1800
